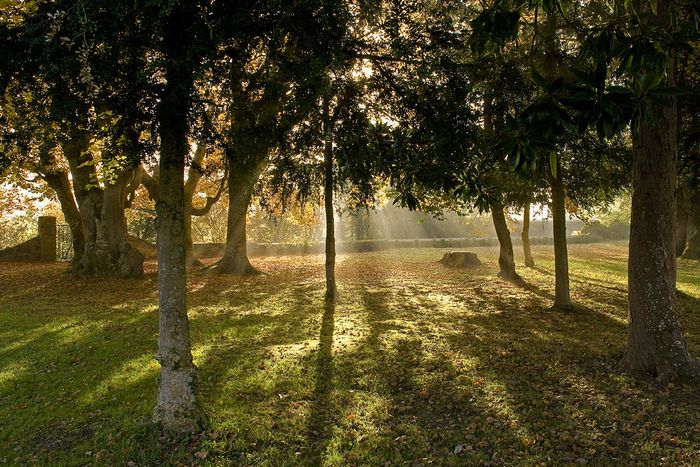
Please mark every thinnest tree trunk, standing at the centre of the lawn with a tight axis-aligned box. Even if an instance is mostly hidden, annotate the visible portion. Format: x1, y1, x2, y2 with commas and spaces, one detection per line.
323, 107, 337, 302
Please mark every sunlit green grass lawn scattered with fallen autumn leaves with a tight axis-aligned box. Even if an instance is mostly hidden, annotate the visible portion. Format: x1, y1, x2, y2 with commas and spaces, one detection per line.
0, 244, 700, 465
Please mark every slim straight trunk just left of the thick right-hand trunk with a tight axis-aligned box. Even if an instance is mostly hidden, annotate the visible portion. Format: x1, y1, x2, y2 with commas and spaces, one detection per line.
548, 158, 572, 311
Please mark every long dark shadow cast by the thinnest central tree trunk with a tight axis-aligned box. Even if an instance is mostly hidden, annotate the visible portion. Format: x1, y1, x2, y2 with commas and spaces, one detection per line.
306, 302, 335, 465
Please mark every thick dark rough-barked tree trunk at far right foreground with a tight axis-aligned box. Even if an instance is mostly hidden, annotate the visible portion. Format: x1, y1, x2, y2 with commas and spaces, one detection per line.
621, 0, 698, 383
